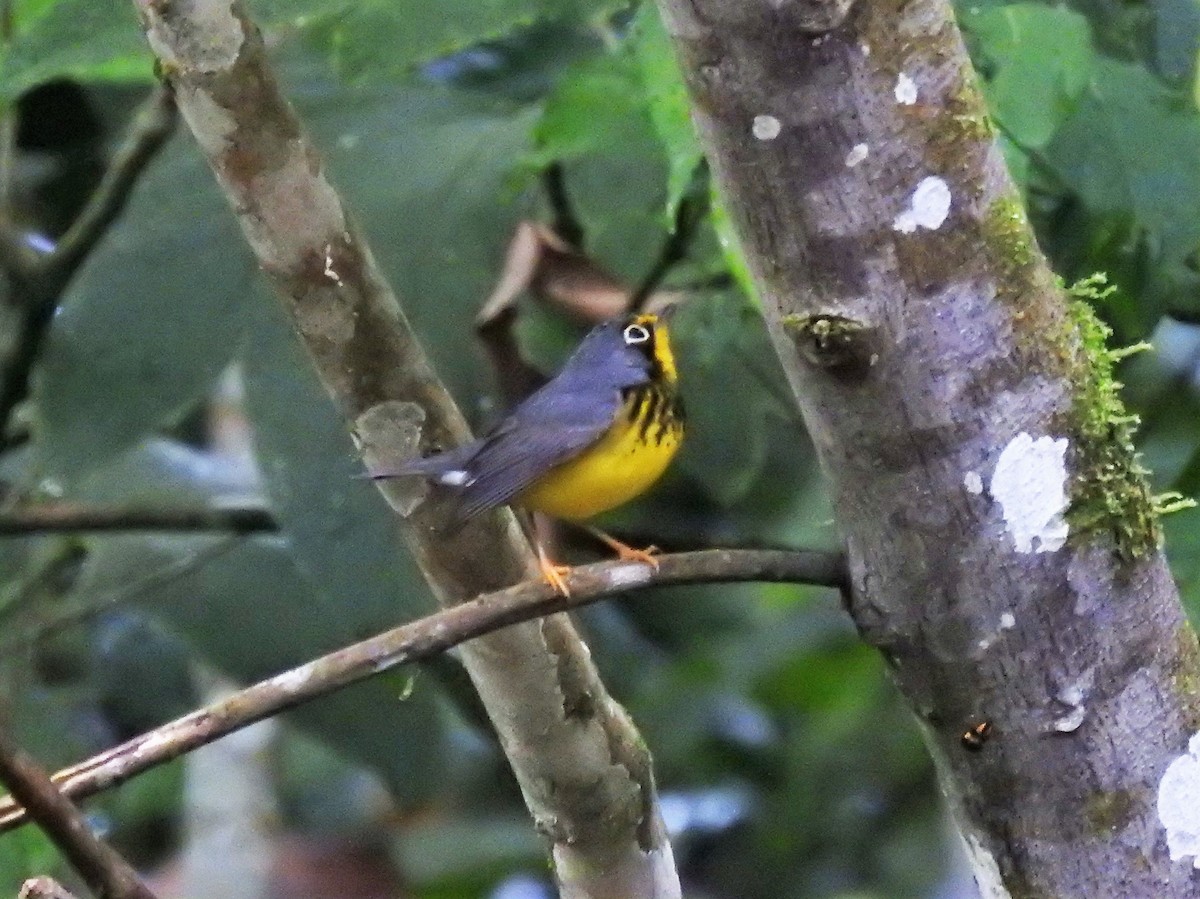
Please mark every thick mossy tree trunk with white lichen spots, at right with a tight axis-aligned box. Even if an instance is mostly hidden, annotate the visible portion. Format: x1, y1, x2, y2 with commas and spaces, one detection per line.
660, 0, 1200, 899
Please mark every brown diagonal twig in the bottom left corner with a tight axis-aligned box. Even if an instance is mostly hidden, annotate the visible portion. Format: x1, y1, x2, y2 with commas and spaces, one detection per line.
0, 730, 155, 899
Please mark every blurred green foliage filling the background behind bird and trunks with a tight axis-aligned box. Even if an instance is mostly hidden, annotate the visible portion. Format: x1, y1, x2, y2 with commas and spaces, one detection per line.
0, 0, 1200, 899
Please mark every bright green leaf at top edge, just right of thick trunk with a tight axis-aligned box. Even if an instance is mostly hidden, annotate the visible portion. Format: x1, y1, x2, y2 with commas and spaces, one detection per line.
962, 4, 1094, 149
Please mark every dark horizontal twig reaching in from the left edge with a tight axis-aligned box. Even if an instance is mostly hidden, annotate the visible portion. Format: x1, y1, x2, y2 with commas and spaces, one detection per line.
0, 503, 278, 537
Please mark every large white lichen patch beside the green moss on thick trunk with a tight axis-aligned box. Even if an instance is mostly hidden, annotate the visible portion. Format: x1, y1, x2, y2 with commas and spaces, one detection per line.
989, 431, 1069, 552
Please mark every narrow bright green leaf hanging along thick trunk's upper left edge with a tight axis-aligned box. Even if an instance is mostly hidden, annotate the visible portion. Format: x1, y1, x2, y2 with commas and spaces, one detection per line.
630, 2, 704, 227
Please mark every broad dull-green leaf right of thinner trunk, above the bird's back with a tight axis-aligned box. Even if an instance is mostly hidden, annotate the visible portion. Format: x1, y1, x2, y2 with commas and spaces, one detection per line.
298, 85, 534, 403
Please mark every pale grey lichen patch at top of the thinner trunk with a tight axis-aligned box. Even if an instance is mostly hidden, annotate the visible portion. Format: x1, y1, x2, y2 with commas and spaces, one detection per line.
138, 0, 246, 72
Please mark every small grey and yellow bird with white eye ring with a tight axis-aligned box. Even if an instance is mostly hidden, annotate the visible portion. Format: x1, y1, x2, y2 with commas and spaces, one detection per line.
373, 314, 684, 595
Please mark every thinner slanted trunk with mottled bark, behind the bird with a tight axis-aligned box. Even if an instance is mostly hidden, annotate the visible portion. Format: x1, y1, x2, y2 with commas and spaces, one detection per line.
137, 0, 679, 899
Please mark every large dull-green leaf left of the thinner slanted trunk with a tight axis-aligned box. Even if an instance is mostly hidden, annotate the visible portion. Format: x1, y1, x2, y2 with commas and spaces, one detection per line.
32, 136, 256, 480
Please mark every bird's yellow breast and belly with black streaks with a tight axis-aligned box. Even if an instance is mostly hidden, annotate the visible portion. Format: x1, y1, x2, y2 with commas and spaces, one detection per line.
516, 385, 683, 521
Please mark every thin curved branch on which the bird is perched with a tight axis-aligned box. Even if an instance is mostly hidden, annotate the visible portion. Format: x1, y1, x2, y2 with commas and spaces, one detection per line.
0, 550, 846, 832
